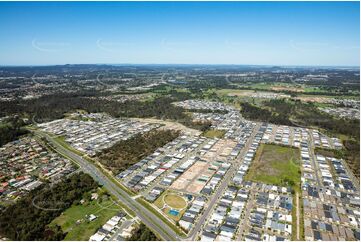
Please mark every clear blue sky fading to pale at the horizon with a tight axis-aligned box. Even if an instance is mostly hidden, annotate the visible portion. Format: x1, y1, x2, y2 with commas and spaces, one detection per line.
0, 2, 360, 66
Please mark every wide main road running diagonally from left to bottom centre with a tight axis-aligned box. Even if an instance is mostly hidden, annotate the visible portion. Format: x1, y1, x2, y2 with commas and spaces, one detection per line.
34, 131, 183, 241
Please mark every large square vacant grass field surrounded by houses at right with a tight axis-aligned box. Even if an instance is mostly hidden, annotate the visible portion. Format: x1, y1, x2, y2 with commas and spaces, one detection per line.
245, 144, 301, 190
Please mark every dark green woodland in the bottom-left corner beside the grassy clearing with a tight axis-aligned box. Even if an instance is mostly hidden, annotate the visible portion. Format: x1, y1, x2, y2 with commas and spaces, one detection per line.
0, 173, 98, 240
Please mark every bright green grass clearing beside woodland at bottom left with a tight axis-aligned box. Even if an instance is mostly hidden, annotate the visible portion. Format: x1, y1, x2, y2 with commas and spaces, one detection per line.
50, 194, 122, 241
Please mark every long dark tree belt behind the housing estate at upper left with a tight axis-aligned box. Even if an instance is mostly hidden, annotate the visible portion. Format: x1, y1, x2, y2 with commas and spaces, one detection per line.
0, 93, 211, 131
